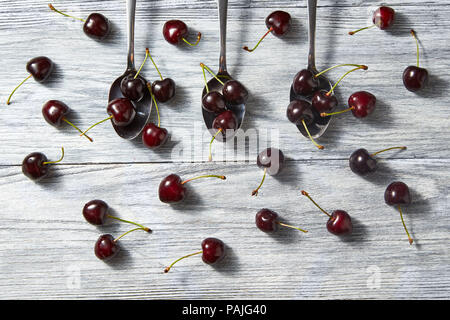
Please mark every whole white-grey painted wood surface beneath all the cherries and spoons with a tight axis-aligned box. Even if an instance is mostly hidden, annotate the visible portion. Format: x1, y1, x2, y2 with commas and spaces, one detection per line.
0, 0, 450, 299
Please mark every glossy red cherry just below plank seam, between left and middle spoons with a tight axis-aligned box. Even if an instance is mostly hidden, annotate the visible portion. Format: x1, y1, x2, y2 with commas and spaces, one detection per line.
158, 174, 226, 203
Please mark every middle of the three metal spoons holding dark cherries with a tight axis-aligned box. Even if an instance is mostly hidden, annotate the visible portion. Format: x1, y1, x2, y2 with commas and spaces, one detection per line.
202, 0, 245, 141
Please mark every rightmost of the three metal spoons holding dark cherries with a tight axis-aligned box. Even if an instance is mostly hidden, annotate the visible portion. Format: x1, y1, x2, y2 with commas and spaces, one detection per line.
290, 0, 332, 138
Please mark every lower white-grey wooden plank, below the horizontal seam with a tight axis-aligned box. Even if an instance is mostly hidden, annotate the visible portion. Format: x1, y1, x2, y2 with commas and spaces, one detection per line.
0, 160, 450, 299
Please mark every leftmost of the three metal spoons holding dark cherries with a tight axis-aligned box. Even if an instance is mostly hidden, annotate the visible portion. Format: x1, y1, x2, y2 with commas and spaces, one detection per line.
108, 0, 153, 140
